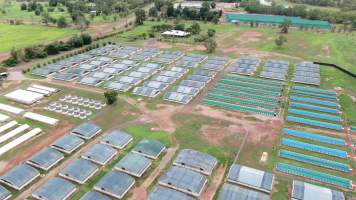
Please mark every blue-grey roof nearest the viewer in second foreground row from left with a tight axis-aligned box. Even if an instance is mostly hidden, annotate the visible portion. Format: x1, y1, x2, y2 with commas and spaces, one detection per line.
32, 177, 76, 200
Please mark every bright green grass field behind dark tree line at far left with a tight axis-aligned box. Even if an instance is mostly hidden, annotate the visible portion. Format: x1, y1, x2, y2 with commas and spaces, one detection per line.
0, 24, 79, 52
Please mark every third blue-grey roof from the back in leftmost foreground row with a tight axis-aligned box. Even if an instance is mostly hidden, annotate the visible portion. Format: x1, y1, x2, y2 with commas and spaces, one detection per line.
27, 147, 64, 170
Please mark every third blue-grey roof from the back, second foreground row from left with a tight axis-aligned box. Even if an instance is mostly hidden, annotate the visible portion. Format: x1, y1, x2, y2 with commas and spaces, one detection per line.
59, 159, 98, 183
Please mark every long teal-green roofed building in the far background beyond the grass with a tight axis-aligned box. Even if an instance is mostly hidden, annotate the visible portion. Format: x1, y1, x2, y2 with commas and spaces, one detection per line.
225, 13, 331, 29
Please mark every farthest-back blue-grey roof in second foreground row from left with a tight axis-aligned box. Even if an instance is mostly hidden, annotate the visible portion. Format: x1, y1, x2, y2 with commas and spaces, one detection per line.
100, 131, 133, 149
